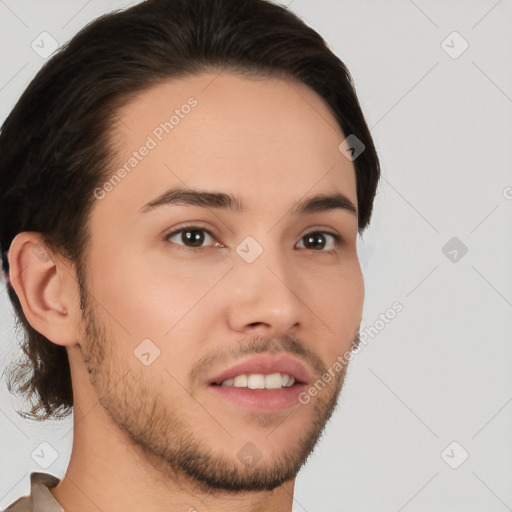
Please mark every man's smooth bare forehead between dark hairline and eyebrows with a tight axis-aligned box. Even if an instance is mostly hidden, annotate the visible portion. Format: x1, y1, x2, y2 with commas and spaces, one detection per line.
95, 72, 357, 222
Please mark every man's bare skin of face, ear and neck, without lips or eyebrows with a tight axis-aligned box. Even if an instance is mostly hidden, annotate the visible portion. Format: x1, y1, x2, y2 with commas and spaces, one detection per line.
9, 72, 364, 512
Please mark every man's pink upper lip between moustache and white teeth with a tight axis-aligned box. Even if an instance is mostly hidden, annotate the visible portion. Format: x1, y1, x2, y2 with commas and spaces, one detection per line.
208, 354, 311, 384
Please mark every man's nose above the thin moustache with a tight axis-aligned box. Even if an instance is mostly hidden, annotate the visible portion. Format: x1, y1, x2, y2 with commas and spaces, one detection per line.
228, 247, 308, 338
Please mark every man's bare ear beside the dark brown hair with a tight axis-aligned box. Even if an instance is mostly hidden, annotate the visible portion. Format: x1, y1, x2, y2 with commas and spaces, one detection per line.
8, 231, 81, 346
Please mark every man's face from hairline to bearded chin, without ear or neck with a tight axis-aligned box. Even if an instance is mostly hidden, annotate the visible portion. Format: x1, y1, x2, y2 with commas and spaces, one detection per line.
77, 73, 364, 490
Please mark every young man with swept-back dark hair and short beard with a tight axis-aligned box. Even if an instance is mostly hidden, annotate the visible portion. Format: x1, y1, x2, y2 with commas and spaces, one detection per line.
0, 0, 379, 512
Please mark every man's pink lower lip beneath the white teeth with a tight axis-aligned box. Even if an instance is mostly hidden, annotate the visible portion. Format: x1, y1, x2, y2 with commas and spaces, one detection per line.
208, 384, 306, 412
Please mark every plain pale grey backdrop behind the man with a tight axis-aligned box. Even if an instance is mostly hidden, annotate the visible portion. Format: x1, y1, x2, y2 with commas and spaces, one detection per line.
0, 0, 512, 512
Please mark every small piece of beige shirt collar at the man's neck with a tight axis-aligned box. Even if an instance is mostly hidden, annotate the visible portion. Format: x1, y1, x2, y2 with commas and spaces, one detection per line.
3, 472, 64, 512
